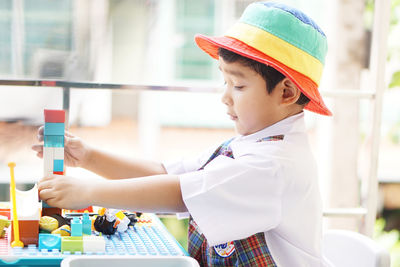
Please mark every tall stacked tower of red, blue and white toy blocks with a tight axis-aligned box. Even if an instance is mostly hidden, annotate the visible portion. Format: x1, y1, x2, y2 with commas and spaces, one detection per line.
42, 109, 65, 215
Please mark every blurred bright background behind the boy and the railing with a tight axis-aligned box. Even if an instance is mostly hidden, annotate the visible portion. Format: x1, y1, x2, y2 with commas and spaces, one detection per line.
0, 0, 400, 266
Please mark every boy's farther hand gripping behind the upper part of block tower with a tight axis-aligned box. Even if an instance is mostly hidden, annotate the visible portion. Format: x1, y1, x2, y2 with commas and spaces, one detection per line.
32, 126, 90, 167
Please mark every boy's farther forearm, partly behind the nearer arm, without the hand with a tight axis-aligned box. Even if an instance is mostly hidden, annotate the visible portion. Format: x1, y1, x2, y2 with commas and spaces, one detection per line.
81, 148, 167, 179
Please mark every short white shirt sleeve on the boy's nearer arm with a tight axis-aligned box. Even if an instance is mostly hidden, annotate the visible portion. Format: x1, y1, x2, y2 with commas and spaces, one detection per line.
180, 156, 285, 246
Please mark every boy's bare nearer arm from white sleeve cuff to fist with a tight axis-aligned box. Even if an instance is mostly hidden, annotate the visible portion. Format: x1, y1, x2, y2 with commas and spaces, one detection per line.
39, 175, 187, 212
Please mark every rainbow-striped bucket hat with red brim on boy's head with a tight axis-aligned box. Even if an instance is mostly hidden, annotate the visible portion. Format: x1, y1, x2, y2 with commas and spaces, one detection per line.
195, 2, 332, 116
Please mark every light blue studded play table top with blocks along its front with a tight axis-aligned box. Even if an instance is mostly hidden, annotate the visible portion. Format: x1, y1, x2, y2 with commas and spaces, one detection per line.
0, 214, 187, 266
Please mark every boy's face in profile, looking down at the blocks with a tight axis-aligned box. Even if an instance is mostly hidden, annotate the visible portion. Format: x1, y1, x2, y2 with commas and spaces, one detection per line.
219, 57, 282, 135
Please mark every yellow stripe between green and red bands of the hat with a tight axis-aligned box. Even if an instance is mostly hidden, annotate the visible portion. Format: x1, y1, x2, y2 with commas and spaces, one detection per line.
225, 22, 323, 85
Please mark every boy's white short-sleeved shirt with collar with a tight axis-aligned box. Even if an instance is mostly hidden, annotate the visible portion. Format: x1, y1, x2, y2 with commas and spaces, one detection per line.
164, 113, 332, 267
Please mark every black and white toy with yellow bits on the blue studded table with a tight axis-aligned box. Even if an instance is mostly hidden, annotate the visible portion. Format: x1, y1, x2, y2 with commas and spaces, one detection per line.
94, 208, 137, 235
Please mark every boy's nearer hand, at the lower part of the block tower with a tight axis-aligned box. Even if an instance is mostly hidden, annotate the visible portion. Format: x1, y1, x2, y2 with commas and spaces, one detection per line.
38, 175, 93, 210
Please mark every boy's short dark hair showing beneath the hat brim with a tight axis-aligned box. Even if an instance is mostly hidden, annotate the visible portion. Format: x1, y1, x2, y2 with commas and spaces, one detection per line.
218, 47, 310, 106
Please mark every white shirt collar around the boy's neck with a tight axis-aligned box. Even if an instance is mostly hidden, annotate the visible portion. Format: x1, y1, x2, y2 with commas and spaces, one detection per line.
232, 112, 306, 142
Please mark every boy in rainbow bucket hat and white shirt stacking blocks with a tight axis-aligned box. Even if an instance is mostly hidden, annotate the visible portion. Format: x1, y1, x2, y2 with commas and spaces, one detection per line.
34, 2, 330, 267
